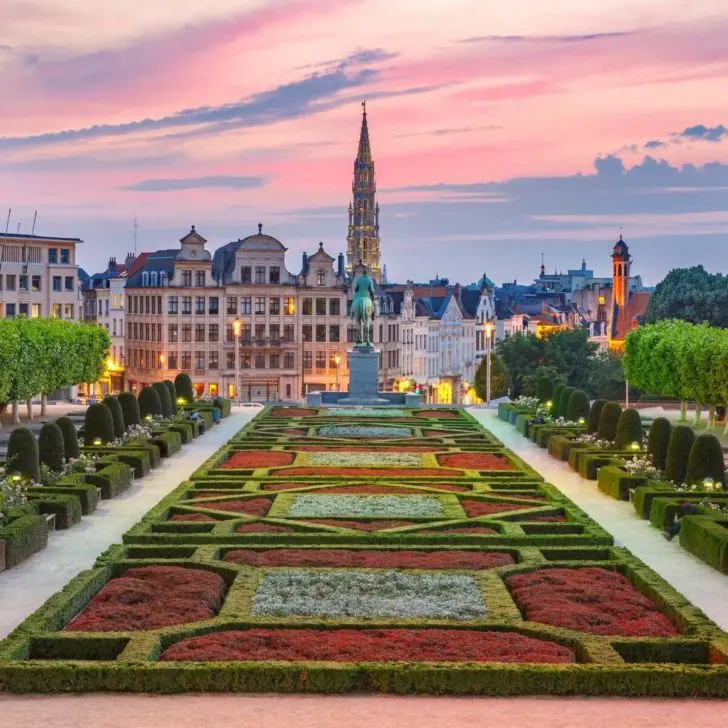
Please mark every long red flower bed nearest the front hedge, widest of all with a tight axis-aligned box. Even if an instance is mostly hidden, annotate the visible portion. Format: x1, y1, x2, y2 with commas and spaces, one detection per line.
159, 629, 576, 663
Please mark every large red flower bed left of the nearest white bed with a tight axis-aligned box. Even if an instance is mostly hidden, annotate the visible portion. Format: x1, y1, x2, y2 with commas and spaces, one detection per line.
66, 566, 226, 632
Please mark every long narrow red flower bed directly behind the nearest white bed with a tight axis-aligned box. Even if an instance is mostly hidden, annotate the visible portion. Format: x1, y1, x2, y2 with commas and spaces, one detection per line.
224, 549, 514, 569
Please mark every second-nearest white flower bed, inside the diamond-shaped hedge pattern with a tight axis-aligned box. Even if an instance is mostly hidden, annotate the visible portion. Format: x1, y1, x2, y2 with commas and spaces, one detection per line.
288, 495, 443, 518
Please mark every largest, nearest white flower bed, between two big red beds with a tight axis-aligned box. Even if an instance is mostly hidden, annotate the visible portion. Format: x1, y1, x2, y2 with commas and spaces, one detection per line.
252, 570, 486, 620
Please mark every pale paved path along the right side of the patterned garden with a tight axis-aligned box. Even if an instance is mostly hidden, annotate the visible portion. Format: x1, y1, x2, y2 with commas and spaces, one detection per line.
470, 409, 728, 628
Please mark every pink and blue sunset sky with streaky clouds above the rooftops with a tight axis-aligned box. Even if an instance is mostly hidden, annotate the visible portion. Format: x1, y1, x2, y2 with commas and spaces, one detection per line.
0, 0, 728, 284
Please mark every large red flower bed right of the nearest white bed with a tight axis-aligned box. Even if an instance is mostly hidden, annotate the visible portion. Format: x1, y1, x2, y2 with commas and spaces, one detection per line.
505, 567, 677, 637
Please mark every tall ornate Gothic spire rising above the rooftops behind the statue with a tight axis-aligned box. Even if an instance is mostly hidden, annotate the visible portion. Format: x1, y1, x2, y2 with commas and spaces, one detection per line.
346, 101, 382, 283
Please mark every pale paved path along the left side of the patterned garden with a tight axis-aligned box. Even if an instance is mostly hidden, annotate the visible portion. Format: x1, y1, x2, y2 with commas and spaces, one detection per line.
0, 407, 260, 639
